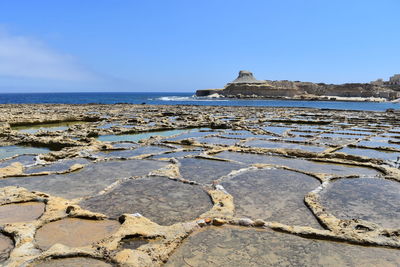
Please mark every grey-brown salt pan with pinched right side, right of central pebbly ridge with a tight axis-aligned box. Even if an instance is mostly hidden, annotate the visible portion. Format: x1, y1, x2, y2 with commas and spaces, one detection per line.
222, 169, 320, 228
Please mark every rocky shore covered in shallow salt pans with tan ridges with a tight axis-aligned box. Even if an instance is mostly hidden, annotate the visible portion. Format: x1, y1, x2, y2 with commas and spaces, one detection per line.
0, 104, 400, 266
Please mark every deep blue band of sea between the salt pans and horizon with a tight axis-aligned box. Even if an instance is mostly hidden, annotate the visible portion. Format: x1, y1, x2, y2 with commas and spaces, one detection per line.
0, 92, 400, 111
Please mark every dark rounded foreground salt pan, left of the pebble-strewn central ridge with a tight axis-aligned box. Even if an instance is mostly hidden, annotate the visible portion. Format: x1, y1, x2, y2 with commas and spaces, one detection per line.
80, 177, 212, 225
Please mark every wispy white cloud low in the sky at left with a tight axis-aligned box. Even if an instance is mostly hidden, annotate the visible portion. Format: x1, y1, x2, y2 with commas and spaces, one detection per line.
0, 29, 98, 82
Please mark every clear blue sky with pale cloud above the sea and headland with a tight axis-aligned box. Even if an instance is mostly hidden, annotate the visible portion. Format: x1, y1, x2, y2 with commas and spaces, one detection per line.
0, 0, 400, 93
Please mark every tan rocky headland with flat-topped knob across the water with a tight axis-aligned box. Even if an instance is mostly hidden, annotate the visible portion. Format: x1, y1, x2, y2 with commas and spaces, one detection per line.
196, 70, 400, 100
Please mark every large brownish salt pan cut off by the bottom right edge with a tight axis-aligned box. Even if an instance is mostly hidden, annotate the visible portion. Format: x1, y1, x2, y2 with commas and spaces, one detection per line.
165, 227, 400, 267
